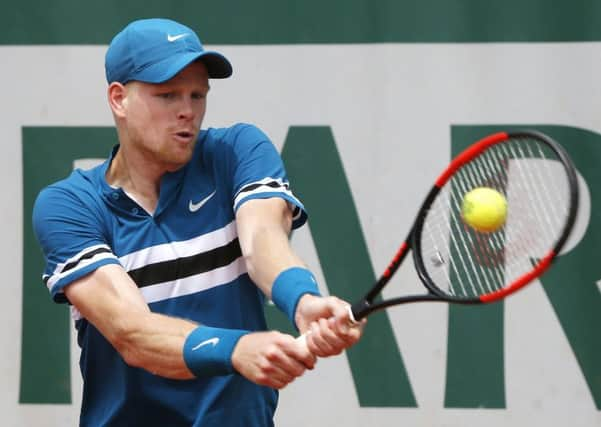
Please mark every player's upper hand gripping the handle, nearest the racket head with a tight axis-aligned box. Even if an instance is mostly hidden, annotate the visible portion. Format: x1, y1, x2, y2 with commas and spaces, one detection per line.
295, 294, 365, 357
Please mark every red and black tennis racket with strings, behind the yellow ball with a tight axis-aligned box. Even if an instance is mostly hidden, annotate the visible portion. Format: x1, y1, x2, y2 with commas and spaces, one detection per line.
316, 131, 578, 330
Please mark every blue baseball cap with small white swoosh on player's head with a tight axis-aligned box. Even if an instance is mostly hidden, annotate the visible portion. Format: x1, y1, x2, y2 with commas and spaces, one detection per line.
104, 18, 232, 84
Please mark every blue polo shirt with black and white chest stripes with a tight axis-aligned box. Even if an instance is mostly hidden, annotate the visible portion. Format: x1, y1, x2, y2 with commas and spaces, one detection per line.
33, 124, 306, 427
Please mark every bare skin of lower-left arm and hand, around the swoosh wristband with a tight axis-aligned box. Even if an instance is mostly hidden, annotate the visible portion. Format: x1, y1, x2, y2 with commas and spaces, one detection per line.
64, 264, 315, 388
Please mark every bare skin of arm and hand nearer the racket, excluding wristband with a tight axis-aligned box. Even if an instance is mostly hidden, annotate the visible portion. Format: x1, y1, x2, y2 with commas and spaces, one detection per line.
236, 197, 361, 357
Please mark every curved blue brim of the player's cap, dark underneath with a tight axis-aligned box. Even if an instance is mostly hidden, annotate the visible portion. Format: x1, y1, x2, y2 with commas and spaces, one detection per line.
131, 51, 232, 83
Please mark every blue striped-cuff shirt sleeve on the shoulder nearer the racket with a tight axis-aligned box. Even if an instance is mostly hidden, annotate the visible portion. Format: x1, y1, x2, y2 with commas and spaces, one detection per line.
228, 125, 307, 228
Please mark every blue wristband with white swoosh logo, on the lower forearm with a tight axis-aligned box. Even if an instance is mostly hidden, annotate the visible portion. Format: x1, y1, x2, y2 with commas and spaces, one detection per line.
184, 325, 249, 377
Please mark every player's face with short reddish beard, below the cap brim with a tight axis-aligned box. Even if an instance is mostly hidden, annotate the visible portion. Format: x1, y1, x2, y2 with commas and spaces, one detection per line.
124, 61, 209, 171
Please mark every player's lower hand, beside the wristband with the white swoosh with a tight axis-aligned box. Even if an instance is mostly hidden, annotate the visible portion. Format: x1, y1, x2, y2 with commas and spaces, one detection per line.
232, 331, 317, 389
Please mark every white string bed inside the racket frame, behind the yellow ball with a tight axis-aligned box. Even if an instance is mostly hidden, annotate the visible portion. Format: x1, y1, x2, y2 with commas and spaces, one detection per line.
420, 138, 570, 299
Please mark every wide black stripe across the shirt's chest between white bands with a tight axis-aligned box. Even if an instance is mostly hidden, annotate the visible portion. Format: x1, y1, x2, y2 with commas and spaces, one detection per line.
127, 238, 242, 288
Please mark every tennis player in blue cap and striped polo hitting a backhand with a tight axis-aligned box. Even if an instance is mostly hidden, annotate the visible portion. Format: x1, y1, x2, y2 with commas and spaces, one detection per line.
33, 19, 361, 427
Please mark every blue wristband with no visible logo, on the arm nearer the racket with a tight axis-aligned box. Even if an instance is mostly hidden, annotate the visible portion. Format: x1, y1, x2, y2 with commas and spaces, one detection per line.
271, 267, 321, 329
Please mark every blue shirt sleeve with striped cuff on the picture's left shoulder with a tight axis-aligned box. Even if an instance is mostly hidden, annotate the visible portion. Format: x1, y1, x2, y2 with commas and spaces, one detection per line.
33, 185, 119, 303
